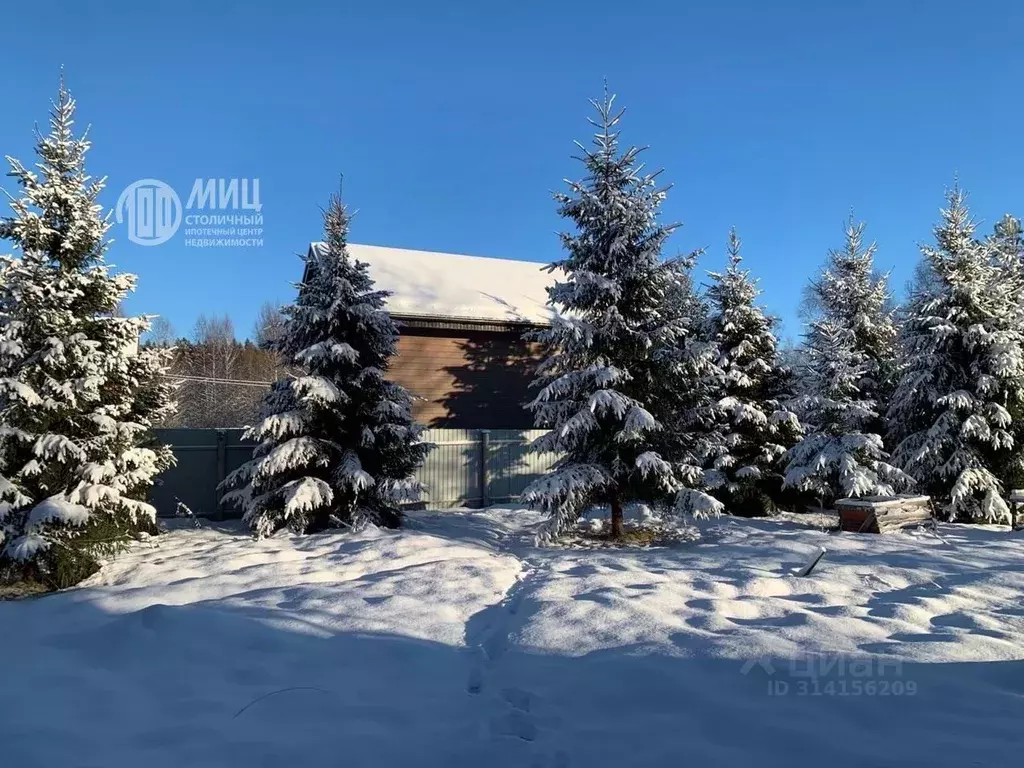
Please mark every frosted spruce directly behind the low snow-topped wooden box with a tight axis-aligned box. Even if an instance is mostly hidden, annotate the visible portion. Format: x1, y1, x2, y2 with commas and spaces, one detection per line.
785, 217, 913, 504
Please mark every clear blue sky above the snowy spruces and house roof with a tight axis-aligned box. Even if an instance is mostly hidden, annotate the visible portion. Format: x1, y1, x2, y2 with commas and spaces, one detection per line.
0, 0, 1024, 336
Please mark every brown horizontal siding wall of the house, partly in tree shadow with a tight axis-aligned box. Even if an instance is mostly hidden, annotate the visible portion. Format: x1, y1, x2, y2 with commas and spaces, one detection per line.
389, 328, 537, 429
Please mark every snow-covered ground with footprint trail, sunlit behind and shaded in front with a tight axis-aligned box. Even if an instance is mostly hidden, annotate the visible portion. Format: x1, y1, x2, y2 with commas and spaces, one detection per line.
0, 509, 1024, 768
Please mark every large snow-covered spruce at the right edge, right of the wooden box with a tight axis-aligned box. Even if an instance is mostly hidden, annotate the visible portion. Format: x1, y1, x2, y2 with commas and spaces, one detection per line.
889, 186, 1024, 522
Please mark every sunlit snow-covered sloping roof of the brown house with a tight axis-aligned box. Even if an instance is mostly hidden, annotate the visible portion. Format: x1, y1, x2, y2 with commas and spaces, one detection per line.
310, 243, 558, 325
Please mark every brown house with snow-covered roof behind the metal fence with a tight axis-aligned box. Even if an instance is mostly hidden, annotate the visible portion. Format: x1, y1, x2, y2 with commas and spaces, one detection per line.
309, 243, 555, 429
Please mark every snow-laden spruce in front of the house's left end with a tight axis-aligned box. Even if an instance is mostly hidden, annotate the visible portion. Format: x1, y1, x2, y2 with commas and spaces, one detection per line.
221, 190, 430, 537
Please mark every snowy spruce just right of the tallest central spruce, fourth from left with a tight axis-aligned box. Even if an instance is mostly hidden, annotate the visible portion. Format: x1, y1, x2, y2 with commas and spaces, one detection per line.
706, 230, 802, 515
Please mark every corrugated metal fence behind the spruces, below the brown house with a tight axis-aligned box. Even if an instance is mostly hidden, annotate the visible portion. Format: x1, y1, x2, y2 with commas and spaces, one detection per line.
152, 429, 557, 518
